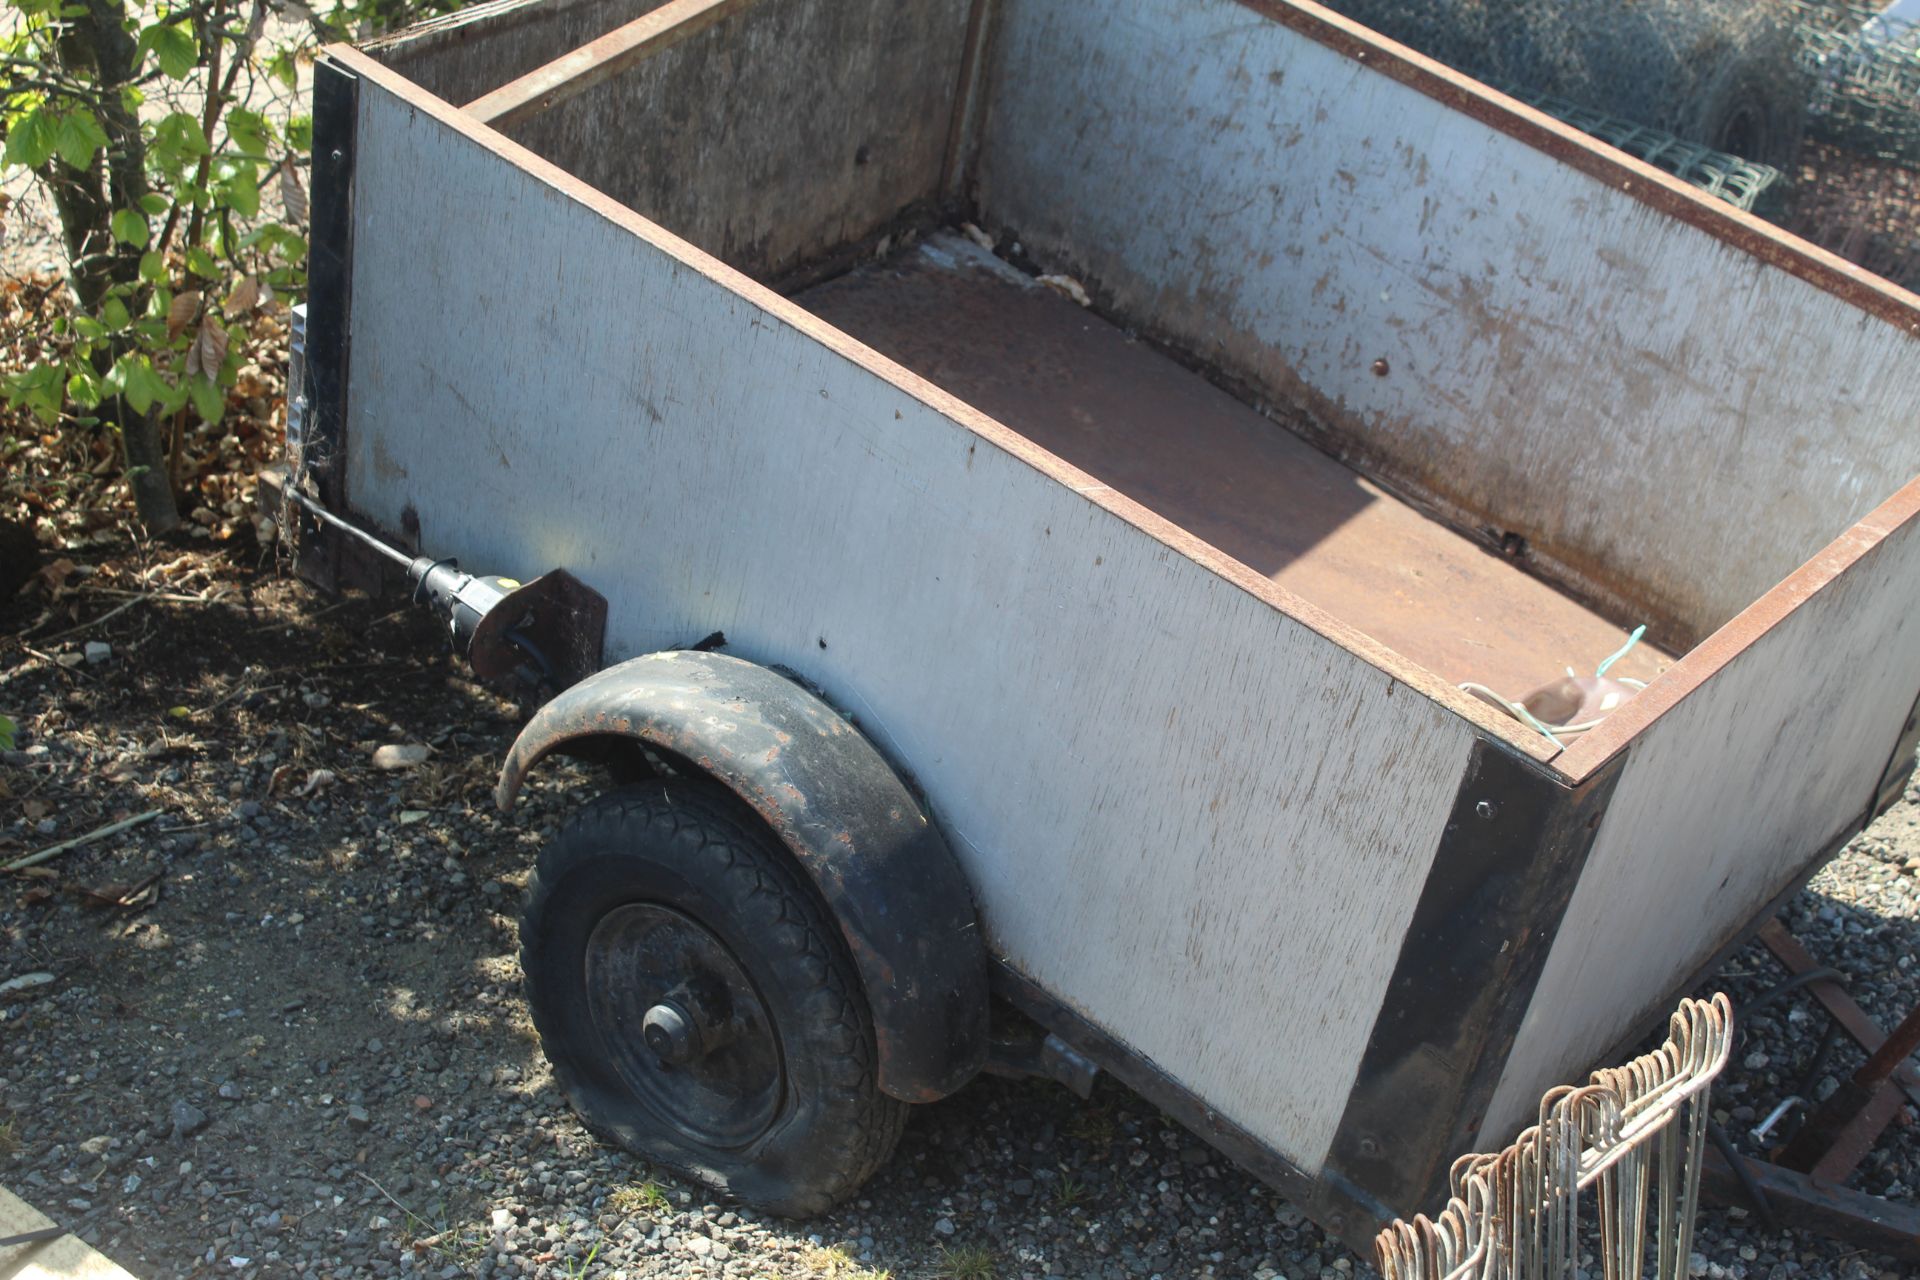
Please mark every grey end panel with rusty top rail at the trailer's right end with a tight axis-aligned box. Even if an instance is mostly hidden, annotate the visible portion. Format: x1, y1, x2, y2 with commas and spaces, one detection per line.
1480, 482, 1920, 1150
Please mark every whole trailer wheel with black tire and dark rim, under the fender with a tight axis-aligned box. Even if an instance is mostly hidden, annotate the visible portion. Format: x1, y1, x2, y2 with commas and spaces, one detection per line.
520, 777, 906, 1217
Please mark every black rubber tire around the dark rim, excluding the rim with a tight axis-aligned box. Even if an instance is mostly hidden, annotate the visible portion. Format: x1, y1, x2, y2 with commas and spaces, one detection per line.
520, 777, 906, 1217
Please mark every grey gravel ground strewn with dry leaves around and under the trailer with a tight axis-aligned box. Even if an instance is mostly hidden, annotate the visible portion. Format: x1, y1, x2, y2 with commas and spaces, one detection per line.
0, 543, 1920, 1280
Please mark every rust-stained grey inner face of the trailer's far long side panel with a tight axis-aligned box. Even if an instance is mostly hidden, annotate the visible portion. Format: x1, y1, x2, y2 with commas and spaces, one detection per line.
979, 0, 1920, 645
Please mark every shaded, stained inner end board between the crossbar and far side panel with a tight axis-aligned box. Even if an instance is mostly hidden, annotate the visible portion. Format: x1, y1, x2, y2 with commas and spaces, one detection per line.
478, 0, 968, 280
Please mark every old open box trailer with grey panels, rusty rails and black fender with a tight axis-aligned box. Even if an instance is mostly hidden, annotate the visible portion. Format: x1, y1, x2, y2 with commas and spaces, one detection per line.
288, 0, 1920, 1249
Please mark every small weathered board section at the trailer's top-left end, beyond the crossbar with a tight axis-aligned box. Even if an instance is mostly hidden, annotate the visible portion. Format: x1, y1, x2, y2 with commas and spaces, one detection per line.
365, 0, 662, 104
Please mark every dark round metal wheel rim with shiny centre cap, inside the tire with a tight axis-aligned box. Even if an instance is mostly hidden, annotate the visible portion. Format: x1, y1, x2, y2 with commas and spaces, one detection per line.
584, 902, 785, 1148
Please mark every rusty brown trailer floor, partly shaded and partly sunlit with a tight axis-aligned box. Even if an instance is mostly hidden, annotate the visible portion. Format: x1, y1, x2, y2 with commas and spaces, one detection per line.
795, 234, 1672, 699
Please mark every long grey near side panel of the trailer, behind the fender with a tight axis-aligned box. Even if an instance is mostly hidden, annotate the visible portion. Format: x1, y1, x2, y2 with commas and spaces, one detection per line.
342, 54, 1475, 1171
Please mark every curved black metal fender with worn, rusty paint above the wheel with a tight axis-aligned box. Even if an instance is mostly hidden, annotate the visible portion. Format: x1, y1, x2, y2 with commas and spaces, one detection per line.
493, 651, 987, 1102
